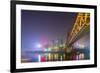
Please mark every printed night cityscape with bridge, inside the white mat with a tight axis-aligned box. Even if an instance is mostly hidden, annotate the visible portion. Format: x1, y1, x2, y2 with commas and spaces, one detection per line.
21, 10, 90, 62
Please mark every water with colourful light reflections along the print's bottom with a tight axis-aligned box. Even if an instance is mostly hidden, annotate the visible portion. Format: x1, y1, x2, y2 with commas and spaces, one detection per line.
22, 48, 90, 62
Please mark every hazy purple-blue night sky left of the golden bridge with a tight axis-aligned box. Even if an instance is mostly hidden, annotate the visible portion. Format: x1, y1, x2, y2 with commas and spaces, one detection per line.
21, 10, 77, 51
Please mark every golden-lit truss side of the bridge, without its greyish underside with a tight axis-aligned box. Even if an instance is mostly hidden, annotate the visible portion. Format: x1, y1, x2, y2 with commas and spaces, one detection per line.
67, 13, 90, 44
